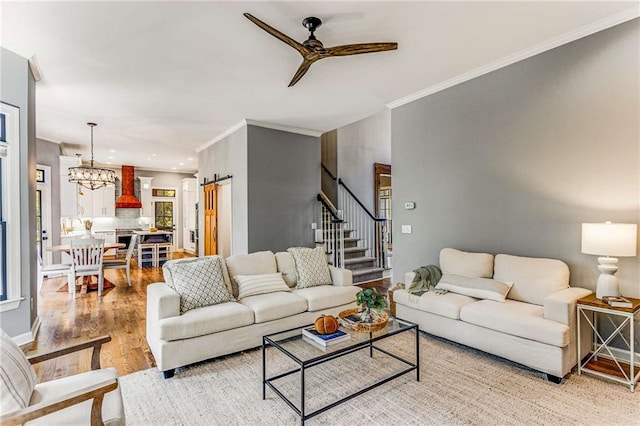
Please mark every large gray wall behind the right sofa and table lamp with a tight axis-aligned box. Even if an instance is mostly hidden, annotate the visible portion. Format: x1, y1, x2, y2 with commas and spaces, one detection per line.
391, 19, 640, 297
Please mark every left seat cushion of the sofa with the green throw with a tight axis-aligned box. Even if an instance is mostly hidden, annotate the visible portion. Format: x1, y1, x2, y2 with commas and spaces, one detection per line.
393, 290, 478, 320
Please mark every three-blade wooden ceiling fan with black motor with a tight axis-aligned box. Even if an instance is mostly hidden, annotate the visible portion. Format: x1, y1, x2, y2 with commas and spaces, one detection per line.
244, 13, 398, 87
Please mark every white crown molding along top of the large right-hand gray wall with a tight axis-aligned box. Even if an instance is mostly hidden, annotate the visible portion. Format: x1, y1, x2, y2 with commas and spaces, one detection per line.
386, 5, 640, 109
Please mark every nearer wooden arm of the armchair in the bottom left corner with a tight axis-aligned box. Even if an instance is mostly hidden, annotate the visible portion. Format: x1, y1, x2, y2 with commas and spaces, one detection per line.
0, 379, 118, 426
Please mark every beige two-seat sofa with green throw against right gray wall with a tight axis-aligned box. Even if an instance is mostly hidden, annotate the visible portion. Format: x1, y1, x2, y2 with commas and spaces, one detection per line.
393, 249, 591, 383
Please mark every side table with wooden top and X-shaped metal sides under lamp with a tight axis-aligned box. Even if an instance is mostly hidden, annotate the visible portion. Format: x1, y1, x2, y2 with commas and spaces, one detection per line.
577, 294, 640, 392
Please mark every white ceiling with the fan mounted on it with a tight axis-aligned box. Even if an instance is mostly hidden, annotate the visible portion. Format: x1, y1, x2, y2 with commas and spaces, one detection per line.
0, 1, 639, 171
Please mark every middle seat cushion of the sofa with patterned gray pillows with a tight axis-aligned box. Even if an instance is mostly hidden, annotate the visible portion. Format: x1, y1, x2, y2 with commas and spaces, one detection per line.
240, 291, 307, 323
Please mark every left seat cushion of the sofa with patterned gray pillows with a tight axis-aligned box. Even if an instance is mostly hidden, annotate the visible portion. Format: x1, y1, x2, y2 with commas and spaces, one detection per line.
158, 302, 253, 341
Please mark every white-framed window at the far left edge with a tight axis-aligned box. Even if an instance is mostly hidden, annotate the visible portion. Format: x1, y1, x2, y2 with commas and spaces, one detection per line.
0, 102, 22, 312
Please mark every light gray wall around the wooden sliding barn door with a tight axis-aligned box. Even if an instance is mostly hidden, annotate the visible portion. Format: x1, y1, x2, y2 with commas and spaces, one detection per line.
198, 126, 249, 254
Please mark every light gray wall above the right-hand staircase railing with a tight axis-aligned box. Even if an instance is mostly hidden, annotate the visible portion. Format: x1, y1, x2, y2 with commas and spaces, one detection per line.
338, 109, 391, 213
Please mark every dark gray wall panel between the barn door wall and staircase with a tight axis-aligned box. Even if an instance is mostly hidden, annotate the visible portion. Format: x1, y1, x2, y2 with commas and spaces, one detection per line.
249, 125, 320, 252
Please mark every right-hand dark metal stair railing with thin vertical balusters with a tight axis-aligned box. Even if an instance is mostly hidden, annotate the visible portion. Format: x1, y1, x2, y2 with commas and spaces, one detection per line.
338, 178, 387, 269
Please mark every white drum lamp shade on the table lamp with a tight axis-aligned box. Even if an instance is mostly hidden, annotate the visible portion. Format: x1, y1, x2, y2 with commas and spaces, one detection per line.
582, 222, 638, 257
